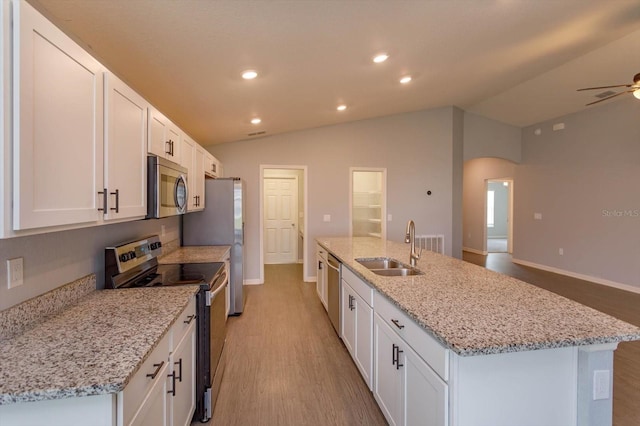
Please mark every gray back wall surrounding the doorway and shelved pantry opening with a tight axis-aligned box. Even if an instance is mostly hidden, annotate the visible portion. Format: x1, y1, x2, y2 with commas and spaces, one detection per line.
207, 107, 462, 280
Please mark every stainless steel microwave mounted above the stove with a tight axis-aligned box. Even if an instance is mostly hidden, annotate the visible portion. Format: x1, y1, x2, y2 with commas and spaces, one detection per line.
147, 155, 189, 219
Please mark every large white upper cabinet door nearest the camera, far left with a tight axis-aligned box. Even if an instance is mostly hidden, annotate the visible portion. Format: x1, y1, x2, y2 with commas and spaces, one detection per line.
13, 2, 103, 230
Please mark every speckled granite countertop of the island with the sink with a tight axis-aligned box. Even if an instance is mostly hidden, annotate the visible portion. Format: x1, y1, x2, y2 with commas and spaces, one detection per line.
316, 238, 640, 356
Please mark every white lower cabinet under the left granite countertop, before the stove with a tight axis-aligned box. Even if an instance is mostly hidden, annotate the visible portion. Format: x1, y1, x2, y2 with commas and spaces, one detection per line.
0, 296, 196, 426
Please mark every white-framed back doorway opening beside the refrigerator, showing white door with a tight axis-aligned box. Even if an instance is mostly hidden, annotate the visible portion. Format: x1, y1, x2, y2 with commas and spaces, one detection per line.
260, 165, 307, 282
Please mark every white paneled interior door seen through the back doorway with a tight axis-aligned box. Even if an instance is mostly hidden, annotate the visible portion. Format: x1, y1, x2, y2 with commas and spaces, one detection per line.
264, 177, 298, 264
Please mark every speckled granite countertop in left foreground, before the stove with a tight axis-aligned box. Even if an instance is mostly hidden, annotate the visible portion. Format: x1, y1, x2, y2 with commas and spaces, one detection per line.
0, 286, 198, 405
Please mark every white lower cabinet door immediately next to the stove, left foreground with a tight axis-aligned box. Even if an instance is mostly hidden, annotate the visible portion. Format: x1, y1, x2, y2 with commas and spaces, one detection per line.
167, 322, 196, 426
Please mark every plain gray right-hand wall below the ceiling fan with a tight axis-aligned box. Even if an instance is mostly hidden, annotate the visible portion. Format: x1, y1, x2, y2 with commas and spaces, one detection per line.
513, 96, 640, 287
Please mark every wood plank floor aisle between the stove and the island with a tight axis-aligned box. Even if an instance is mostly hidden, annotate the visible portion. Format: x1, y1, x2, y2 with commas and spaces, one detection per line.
200, 265, 387, 426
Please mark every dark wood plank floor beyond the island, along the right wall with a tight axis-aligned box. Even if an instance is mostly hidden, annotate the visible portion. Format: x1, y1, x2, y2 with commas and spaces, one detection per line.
463, 252, 640, 426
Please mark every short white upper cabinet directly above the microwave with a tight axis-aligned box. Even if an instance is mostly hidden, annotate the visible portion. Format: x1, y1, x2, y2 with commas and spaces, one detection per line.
148, 107, 182, 164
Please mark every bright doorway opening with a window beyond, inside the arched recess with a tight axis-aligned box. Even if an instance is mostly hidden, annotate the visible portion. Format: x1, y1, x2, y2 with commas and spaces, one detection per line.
485, 179, 513, 253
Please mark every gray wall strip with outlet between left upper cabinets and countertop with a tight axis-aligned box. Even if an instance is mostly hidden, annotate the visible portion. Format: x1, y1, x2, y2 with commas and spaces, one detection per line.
0, 217, 179, 310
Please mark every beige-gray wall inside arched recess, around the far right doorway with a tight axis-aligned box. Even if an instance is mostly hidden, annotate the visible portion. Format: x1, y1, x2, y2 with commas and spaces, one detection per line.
463, 158, 518, 252
